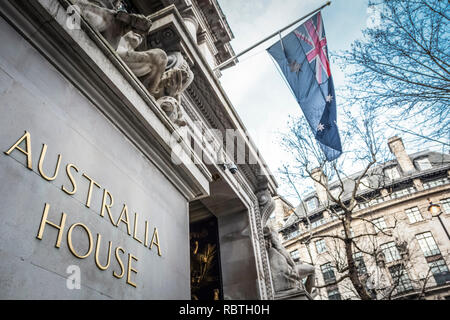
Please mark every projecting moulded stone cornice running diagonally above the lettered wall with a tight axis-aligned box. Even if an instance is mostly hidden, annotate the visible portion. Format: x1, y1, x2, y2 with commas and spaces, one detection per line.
0, 0, 212, 200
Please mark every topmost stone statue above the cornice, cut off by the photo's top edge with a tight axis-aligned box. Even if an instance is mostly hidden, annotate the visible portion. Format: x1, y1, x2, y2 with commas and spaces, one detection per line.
74, 0, 152, 50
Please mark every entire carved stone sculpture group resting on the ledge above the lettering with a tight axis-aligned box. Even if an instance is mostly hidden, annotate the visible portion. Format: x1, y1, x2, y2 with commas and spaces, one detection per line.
74, 0, 194, 127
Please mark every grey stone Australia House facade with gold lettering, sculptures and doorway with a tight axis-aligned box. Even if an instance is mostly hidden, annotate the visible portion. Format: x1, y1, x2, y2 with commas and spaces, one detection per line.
0, 0, 277, 299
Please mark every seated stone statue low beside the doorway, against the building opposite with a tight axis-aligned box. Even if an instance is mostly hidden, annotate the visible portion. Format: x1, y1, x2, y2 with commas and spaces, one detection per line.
264, 227, 315, 293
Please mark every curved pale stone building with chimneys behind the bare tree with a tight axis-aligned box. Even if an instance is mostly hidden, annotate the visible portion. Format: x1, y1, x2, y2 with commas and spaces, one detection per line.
279, 137, 450, 300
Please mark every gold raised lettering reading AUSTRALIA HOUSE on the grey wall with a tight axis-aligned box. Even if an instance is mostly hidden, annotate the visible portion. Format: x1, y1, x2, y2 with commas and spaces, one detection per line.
4, 131, 162, 288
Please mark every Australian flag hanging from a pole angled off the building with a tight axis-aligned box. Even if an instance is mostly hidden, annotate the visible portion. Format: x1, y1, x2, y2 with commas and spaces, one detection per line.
267, 12, 342, 161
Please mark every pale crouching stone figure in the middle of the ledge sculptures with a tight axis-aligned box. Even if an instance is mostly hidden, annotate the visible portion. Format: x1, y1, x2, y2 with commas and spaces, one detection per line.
117, 31, 168, 96
